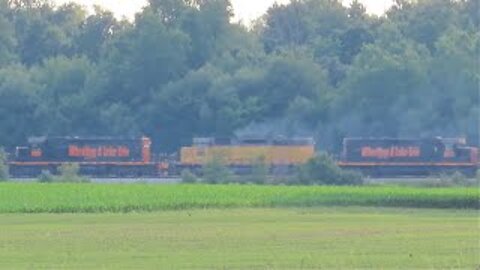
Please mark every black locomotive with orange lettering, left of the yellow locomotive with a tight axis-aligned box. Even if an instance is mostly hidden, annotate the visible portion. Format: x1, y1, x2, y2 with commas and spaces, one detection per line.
9, 137, 157, 177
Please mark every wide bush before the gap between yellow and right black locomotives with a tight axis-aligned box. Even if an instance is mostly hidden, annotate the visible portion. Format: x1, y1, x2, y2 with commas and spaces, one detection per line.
297, 153, 363, 185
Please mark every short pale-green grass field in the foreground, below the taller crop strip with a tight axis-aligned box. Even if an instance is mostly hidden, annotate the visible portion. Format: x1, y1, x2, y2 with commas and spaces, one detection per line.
0, 207, 480, 269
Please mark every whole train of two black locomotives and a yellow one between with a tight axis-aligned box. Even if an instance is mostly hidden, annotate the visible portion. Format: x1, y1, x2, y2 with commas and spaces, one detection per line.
4, 137, 479, 178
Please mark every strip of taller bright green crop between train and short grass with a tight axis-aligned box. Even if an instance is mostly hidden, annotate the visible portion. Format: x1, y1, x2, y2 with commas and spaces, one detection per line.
0, 183, 480, 213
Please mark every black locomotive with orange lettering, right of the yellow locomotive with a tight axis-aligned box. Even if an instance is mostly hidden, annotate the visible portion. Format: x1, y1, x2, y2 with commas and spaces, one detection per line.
338, 138, 478, 177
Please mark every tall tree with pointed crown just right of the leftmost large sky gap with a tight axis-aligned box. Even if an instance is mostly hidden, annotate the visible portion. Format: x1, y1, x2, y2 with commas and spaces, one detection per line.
101, 9, 190, 106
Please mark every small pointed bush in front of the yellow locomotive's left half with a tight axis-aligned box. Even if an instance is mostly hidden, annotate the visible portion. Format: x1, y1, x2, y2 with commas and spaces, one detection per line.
202, 155, 234, 184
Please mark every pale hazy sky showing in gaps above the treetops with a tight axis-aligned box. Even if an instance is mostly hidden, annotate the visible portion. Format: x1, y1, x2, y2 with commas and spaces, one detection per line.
55, 0, 392, 22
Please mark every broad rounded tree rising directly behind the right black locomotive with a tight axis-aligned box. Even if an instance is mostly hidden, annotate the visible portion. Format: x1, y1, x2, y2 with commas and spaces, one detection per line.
337, 31, 430, 137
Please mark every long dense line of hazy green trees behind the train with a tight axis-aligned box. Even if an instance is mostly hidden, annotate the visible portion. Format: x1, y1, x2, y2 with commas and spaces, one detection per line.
0, 0, 480, 152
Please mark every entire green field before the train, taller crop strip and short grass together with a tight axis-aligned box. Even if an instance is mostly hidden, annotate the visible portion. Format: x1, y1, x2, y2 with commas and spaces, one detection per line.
0, 183, 480, 269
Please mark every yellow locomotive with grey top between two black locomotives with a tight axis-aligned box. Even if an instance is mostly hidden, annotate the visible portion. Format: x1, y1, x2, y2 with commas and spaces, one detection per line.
180, 138, 315, 172
